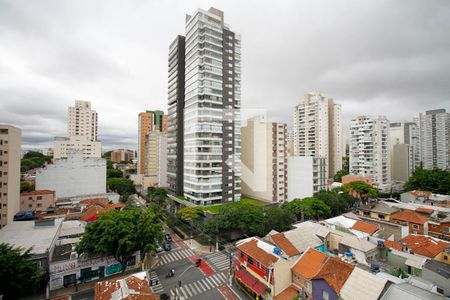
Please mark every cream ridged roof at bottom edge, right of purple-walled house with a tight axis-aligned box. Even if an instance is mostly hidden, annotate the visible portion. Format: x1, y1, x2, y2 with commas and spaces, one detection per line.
340, 267, 388, 300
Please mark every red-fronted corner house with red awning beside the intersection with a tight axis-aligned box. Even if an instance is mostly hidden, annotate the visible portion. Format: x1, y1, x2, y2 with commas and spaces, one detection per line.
234, 237, 293, 299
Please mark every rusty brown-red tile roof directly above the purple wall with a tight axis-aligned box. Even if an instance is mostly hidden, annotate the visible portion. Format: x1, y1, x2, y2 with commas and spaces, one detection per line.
314, 256, 355, 294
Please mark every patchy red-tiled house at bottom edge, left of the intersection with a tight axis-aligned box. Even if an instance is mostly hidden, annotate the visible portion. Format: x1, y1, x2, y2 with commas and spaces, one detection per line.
95, 272, 159, 300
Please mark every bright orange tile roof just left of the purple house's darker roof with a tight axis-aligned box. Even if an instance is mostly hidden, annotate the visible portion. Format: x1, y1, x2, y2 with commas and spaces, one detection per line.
292, 248, 330, 279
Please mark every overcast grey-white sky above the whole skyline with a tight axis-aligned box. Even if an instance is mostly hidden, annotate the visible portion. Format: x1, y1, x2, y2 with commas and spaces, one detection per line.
0, 0, 450, 149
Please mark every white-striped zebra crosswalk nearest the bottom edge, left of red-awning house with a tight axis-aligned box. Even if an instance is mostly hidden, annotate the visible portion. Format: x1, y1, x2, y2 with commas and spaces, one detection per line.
170, 273, 227, 299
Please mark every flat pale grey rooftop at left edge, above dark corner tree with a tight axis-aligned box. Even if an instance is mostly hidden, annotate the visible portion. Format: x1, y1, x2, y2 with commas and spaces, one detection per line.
0, 218, 63, 255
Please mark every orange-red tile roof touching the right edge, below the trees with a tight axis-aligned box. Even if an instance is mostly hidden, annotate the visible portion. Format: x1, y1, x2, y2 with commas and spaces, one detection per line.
402, 234, 450, 258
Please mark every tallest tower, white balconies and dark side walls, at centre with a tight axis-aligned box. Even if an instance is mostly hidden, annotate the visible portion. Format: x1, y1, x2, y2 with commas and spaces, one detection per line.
169, 8, 241, 205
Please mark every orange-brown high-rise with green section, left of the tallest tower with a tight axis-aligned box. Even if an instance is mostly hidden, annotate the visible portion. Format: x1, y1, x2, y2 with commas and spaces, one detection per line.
138, 110, 168, 174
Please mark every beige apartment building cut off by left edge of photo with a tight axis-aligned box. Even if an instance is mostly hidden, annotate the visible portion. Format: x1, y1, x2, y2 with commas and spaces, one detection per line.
0, 124, 22, 228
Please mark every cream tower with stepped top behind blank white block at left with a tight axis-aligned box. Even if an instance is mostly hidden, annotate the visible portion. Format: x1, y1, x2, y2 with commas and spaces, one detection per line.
67, 100, 97, 141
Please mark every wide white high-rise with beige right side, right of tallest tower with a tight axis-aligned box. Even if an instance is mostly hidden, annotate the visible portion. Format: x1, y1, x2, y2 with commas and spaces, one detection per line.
293, 92, 344, 177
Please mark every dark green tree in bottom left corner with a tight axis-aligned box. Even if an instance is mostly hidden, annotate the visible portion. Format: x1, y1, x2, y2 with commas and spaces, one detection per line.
0, 243, 42, 299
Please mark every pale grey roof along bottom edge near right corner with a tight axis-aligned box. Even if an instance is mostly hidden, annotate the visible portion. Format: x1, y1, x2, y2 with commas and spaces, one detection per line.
380, 282, 446, 300
